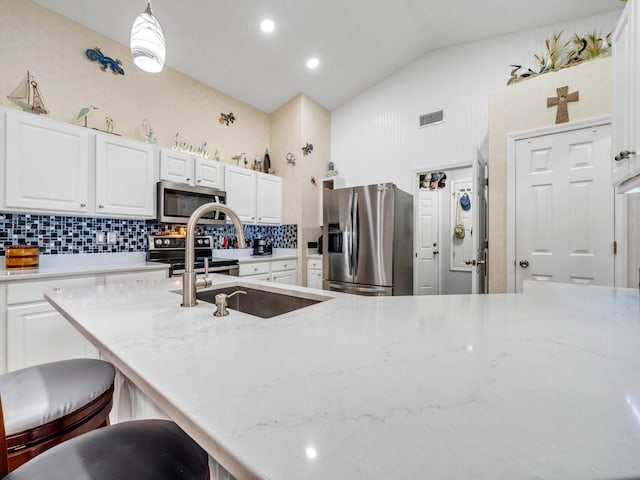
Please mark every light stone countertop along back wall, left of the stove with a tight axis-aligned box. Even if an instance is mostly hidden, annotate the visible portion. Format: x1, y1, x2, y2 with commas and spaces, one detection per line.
0, 252, 169, 283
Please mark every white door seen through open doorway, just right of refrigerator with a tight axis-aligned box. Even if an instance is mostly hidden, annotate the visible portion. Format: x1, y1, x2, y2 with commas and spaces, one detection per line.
414, 190, 440, 295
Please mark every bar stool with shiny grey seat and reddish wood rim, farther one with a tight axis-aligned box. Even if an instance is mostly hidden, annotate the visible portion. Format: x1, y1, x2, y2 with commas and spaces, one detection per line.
0, 358, 115, 471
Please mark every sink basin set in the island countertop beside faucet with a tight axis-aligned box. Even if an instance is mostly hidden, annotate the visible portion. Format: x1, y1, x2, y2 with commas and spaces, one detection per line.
196, 285, 331, 318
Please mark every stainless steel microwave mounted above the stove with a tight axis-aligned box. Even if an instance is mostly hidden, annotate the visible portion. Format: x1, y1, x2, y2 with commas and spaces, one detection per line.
157, 182, 227, 225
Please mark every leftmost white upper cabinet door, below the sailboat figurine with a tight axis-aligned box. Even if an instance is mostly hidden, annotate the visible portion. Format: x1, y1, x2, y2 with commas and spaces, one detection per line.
4, 111, 89, 213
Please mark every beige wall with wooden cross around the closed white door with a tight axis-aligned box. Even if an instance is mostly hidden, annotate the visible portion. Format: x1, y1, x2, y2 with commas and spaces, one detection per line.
489, 58, 612, 293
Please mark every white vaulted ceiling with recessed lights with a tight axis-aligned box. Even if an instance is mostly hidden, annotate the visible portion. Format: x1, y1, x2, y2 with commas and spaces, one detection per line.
35, 0, 624, 113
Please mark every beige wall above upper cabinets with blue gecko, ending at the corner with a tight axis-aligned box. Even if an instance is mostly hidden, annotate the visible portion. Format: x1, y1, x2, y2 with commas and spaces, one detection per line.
0, 0, 270, 169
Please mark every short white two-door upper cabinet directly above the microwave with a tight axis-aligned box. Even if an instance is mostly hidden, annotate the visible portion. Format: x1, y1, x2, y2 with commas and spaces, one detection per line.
160, 148, 224, 189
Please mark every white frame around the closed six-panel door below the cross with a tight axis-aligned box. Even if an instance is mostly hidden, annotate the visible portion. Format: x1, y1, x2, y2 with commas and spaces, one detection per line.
505, 116, 627, 293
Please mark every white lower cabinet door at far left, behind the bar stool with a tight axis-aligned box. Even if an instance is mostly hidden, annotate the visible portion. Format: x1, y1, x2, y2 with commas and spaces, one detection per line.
7, 302, 98, 371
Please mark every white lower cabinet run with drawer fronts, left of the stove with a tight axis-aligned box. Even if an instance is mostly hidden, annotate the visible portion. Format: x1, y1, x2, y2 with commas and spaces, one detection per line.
0, 270, 167, 373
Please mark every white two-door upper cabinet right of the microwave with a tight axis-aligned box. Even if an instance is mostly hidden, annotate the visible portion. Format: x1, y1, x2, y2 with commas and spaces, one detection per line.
225, 165, 282, 225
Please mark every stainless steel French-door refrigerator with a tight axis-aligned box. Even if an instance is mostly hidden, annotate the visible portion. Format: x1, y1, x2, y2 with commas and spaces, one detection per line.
322, 183, 413, 296
